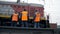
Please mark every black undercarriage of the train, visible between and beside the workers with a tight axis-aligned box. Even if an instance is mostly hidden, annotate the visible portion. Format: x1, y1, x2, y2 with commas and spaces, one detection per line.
0, 17, 50, 28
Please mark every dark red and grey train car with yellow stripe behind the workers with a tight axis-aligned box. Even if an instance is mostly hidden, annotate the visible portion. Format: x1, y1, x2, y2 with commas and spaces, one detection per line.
0, 2, 47, 28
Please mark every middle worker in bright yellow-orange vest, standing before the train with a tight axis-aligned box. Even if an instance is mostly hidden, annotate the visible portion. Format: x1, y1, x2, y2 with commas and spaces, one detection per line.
21, 9, 28, 27
